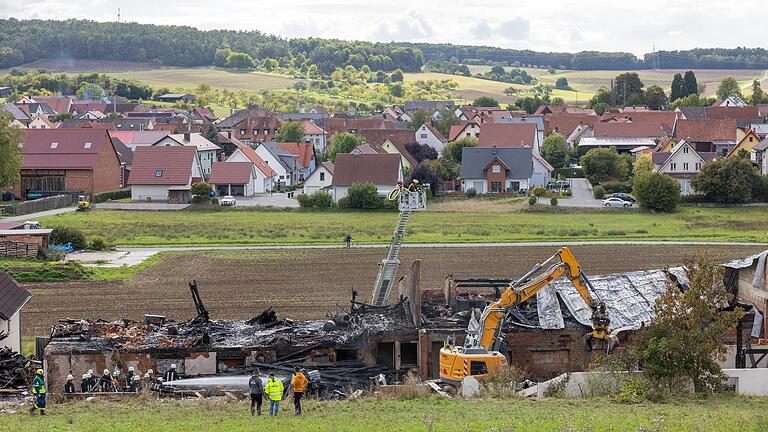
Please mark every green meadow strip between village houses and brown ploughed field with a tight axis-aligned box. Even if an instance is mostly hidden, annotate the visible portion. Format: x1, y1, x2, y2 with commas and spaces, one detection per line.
40, 207, 768, 246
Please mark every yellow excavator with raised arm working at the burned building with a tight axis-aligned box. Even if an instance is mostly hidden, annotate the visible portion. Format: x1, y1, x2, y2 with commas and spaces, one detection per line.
440, 247, 610, 384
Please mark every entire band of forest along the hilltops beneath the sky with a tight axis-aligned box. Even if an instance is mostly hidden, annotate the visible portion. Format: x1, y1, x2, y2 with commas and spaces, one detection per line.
0, 18, 768, 72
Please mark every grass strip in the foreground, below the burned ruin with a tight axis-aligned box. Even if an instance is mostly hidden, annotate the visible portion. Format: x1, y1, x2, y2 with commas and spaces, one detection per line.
7, 396, 768, 432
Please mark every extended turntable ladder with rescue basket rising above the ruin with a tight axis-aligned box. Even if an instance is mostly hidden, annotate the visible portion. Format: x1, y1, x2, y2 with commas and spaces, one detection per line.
371, 189, 429, 306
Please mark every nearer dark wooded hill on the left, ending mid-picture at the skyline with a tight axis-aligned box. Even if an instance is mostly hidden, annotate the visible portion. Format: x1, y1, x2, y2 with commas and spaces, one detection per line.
0, 18, 423, 74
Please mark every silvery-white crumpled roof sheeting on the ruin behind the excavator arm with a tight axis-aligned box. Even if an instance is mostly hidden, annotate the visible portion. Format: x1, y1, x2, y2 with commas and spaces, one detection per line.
536, 267, 687, 330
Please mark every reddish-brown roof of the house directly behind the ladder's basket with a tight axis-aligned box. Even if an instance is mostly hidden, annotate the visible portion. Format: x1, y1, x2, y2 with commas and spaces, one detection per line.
332, 153, 400, 187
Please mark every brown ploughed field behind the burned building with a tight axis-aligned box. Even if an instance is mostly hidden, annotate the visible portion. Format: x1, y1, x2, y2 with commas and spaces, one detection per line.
22, 245, 761, 337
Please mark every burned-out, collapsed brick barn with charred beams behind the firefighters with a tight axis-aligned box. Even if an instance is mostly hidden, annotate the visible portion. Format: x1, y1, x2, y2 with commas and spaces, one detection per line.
44, 261, 683, 392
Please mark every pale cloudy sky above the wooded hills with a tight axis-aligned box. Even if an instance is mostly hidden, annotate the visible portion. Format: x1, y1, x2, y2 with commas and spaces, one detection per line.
0, 0, 768, 55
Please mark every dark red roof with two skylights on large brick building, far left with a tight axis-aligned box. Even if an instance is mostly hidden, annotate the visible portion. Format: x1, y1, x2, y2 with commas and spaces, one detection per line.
22, 129, 114, 169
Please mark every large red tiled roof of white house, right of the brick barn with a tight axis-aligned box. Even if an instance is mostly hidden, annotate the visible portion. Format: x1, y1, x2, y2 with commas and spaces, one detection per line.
128, 146, 197, 185
